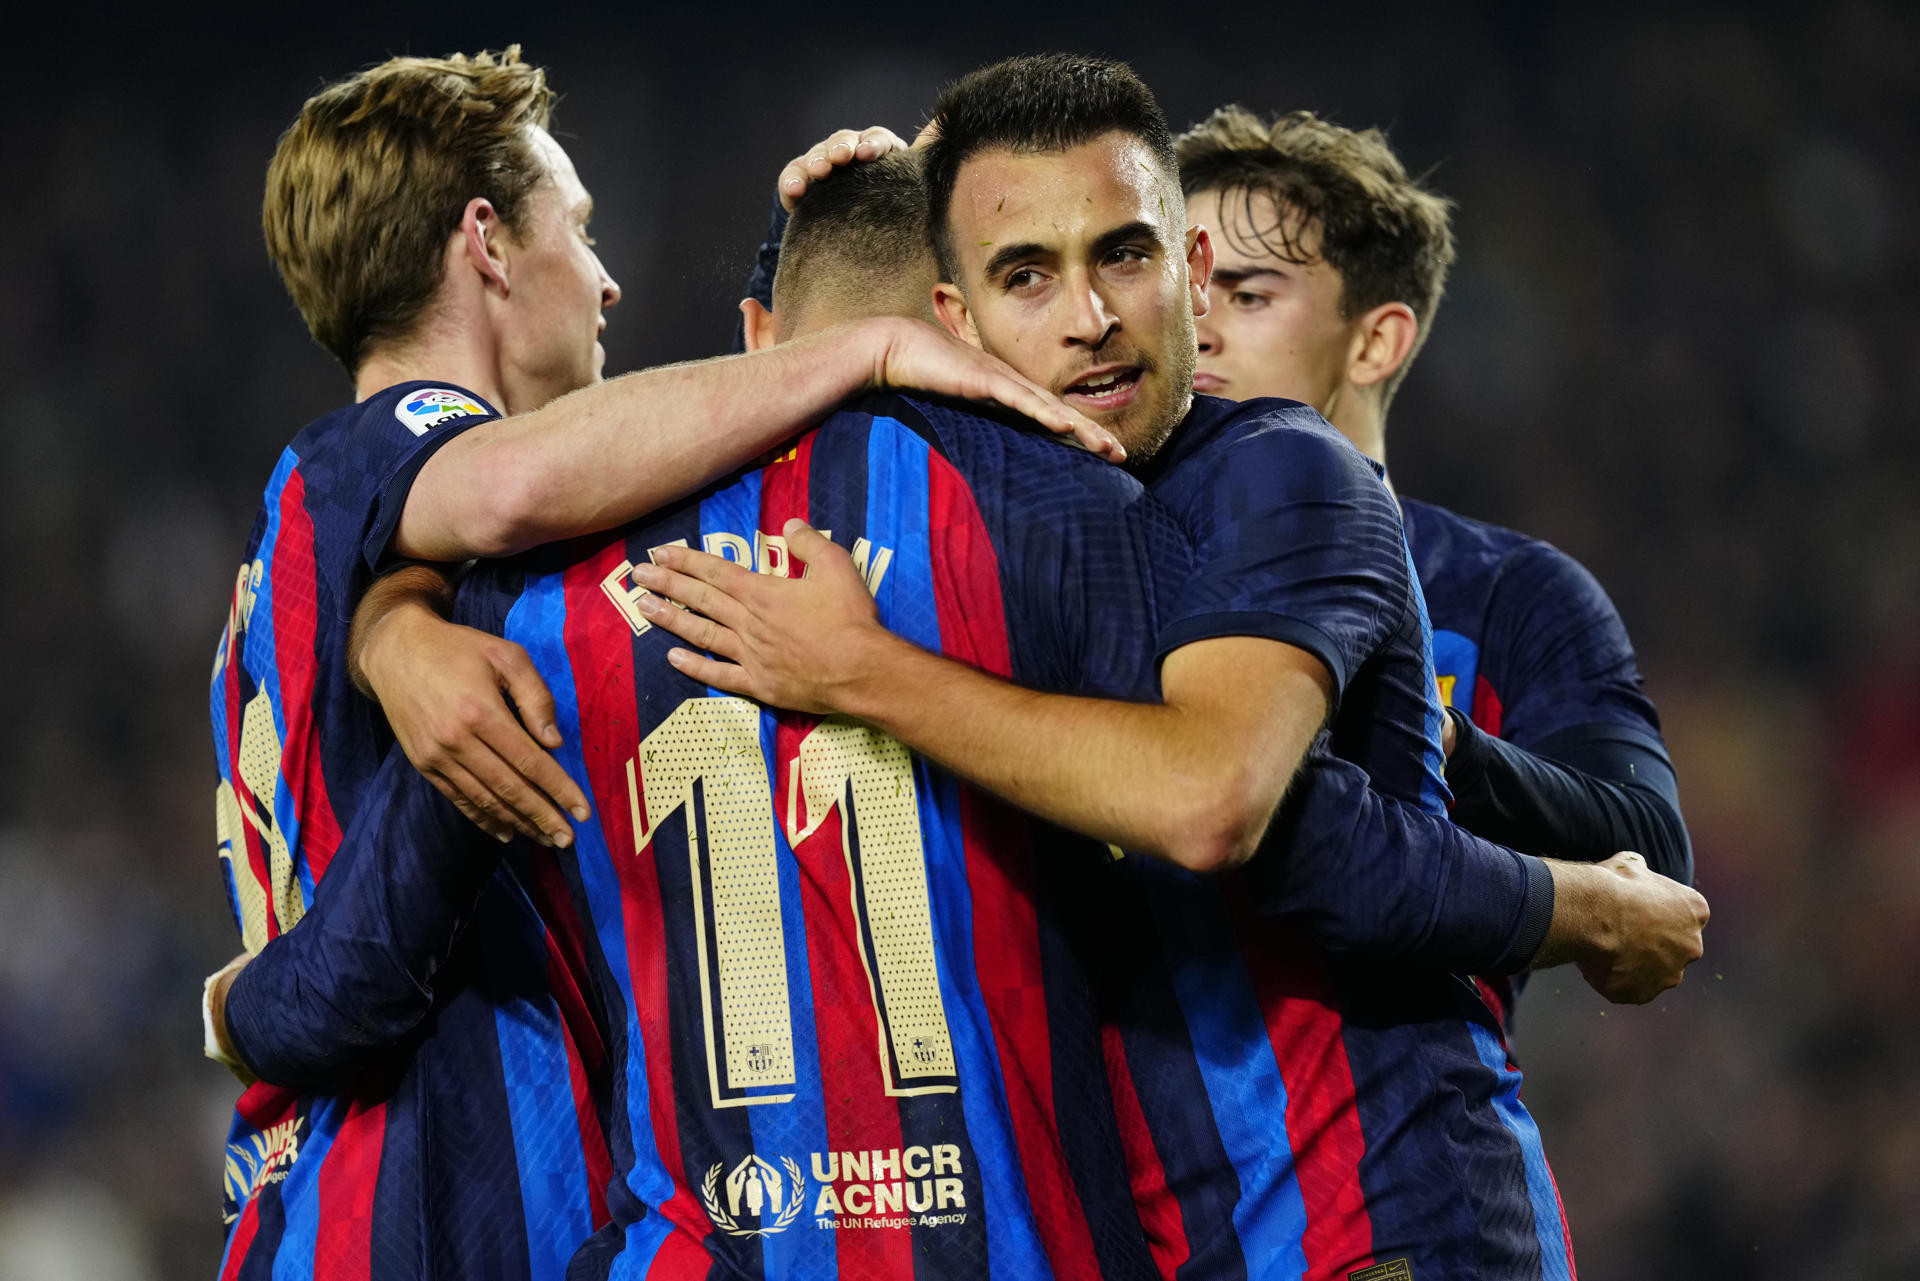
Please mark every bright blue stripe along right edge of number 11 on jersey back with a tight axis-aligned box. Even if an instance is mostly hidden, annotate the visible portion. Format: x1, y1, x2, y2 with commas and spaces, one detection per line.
866, 419, 1052, 1277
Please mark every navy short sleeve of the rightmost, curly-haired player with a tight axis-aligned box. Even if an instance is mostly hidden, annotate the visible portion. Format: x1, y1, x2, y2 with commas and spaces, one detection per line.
1482, 542, 1661, 751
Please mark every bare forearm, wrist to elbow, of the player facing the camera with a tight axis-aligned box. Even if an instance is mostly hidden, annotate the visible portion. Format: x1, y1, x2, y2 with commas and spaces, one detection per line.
843, 636, 1325, 872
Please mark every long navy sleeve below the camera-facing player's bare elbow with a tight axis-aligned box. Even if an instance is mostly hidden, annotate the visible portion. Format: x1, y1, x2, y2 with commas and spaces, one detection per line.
1248, 751, 1553, 974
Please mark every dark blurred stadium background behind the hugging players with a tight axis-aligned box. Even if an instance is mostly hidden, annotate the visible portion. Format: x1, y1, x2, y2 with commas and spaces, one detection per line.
0, 0, 1920, 1281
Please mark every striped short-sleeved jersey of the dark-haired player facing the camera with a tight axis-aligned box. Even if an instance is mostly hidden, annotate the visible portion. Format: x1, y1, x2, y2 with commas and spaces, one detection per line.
1100, 398, 1572, 1279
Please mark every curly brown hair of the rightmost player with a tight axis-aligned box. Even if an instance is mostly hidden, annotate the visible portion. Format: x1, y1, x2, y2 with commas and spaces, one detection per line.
1173, 108, 1453, 401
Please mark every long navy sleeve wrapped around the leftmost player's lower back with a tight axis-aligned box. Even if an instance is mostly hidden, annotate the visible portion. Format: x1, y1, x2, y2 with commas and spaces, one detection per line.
227, 747, 503, 1089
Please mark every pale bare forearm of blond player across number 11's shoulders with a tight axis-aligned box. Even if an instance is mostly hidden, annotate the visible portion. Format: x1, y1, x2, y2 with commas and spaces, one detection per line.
394, 321, 895, 561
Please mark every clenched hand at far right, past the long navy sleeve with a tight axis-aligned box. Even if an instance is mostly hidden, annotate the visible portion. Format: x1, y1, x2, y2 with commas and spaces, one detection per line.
1542, 853, 1709, 1004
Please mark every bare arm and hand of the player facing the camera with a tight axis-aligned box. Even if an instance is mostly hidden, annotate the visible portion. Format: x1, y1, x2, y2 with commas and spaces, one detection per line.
634, 520, 1331, 872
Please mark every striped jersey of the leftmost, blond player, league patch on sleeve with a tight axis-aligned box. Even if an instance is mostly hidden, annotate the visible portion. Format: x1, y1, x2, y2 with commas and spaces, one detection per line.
211, 382, 597, 1279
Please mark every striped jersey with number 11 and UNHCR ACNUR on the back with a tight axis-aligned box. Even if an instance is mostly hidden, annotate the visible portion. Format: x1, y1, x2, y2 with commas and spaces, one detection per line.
437, 398, 1187, 1281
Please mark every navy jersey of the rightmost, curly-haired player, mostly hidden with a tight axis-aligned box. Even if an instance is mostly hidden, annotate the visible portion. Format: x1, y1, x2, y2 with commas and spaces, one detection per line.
1400, 497, 1692, 1027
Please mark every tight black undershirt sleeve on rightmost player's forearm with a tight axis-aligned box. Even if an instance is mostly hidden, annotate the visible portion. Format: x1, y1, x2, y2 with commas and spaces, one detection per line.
1446, 709, 1693, 885
